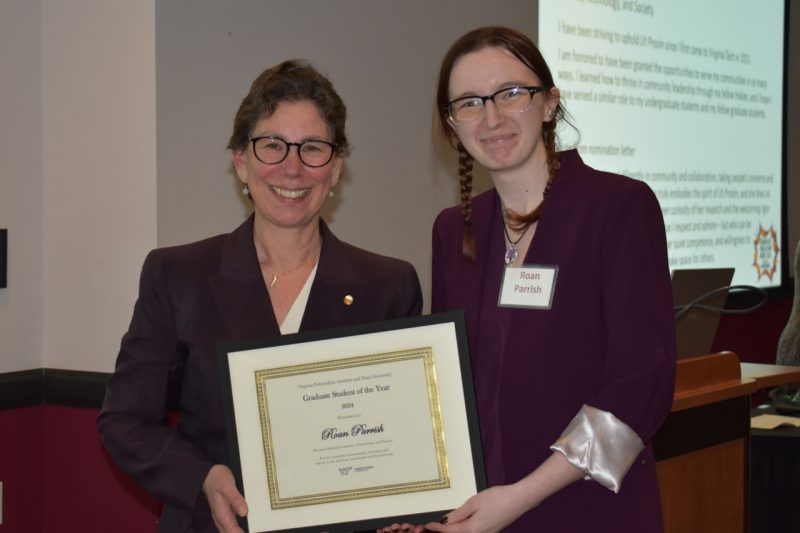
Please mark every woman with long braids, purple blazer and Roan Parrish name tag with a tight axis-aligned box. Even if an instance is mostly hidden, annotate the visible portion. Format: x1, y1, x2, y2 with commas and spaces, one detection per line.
425, 27, 675, 533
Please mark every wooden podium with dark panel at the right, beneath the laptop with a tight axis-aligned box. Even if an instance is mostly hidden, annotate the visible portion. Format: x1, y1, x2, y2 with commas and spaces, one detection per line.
653, 352, 800, 533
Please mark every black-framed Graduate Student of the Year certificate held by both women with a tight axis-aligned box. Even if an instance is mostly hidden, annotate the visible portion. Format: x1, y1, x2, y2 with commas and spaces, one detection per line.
219, 313, 486, 533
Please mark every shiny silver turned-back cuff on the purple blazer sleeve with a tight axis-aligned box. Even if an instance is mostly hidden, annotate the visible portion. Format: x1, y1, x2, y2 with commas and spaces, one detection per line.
550, 405, 644, 492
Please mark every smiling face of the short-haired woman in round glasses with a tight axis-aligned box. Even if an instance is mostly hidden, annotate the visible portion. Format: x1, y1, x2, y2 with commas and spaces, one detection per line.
233, 100, 342, 232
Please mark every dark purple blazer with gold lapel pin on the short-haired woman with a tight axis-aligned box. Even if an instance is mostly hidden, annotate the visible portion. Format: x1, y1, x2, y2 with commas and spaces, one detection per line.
98, 216, 422, 532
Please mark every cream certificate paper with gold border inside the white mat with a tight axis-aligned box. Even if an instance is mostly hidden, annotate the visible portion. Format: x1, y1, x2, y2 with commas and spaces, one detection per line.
255, 348, 450, 509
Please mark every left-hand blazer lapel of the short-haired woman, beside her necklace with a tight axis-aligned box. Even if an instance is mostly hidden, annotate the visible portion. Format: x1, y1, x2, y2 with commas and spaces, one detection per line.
209, 215, 280, 340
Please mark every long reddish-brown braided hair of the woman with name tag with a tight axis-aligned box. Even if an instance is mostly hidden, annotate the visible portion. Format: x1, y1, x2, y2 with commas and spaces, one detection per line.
435, 26, 565, 261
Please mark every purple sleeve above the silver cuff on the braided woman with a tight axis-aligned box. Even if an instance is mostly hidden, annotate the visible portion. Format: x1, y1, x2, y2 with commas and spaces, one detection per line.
590, 182, 675, 442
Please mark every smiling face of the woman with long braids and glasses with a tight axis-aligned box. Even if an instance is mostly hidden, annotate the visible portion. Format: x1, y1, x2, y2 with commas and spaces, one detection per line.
448, 47, 558, 177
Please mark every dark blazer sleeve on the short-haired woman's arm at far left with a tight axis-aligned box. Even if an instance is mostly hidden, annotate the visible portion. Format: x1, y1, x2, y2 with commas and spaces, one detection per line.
98, 251, 213, 516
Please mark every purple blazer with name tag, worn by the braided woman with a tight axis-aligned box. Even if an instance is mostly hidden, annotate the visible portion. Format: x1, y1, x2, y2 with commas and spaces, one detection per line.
431, 150, 675, 533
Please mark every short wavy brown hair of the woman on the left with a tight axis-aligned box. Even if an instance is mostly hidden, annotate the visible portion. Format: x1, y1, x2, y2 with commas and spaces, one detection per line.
228, 59, 350, 156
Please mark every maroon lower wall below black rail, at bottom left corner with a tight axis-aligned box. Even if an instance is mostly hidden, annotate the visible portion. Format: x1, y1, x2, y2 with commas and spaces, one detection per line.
0, 405, 159, 533
